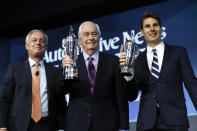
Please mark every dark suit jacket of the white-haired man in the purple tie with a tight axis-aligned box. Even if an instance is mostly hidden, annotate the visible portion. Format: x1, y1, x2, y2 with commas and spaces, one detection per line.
65, 53, 129, 131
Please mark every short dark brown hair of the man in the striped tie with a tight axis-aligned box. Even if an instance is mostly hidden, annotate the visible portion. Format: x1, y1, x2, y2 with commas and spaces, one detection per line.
140, 11, 161, 29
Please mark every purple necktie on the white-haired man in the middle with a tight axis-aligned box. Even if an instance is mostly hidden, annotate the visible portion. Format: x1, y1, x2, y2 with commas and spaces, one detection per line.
88, 56, 96, 93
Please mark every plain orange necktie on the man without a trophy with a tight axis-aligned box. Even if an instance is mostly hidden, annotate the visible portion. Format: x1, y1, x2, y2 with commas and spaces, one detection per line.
31, 63, 41, 123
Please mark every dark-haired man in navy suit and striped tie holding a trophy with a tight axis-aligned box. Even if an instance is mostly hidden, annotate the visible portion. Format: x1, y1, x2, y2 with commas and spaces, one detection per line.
120, 12, 197, 131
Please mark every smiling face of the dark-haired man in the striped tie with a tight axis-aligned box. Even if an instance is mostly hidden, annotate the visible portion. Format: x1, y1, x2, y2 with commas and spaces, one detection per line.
141, 17, 161, 47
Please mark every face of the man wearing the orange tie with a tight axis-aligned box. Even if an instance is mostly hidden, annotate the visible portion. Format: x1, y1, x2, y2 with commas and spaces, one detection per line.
25, 31, 47, 60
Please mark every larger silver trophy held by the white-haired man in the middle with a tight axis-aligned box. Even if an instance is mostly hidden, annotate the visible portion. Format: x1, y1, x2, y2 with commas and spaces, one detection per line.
62, 25, 79, 79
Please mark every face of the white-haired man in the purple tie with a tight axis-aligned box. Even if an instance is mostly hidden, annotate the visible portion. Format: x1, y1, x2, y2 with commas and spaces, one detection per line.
79, 22, 99, 56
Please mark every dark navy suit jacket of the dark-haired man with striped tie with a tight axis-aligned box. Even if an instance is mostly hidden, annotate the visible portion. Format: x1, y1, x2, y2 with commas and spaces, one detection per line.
127, 44, 197, 129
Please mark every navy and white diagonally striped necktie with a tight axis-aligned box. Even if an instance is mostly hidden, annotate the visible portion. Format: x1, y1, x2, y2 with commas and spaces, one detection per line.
151, 49, 159, 79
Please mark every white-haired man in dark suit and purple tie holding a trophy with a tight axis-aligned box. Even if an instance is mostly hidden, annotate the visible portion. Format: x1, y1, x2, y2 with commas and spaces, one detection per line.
62, 21, 129, 131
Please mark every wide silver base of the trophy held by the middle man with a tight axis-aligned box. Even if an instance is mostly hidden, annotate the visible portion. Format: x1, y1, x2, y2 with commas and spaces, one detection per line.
63, 66, 79, 80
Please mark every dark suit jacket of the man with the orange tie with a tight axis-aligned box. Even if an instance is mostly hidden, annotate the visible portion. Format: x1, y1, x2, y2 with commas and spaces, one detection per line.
0, 60, 64, 131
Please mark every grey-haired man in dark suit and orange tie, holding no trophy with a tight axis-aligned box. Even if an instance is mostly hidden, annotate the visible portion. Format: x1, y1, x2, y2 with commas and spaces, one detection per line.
0, 30, 66, 131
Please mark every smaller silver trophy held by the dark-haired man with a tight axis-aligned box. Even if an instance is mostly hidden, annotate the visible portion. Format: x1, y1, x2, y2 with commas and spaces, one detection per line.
120, 36, 139, 76
